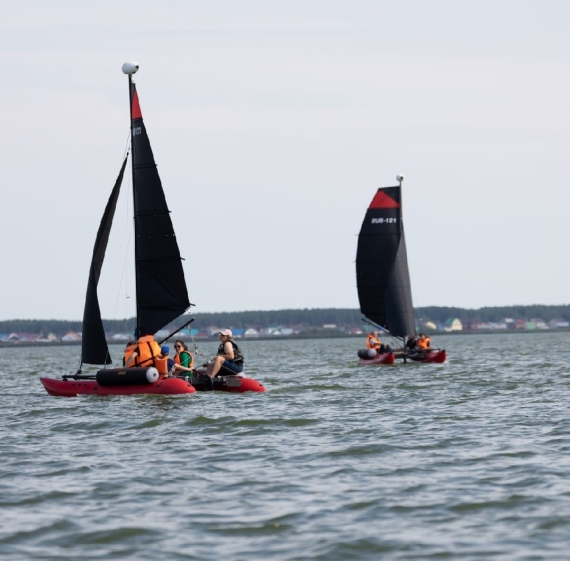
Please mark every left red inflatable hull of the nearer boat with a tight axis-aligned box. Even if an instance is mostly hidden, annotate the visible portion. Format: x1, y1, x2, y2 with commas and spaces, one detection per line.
40, 378, 196, 397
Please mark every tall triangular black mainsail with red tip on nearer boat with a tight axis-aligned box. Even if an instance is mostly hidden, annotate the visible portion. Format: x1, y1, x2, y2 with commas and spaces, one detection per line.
131, 83, 190, 336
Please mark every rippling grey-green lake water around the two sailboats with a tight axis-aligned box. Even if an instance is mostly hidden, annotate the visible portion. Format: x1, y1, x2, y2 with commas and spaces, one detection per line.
0, 333, 570, 561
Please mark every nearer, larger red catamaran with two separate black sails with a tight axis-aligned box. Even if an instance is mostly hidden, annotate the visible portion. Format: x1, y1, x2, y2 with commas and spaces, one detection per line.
41, 62, 264, 397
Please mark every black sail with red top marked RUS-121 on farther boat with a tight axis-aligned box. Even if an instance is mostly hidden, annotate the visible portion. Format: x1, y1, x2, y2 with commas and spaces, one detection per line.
356, 186, 416, 337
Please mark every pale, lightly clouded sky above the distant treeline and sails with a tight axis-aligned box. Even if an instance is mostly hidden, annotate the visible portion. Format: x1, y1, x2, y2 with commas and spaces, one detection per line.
0, 0, 570, 320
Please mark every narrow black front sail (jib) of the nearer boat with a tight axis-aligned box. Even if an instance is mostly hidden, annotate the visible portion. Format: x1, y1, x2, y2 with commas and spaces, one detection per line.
81, 158, 127, 364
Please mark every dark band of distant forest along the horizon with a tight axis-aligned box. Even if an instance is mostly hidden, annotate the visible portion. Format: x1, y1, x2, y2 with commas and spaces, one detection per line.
0, 305, 570, 337
